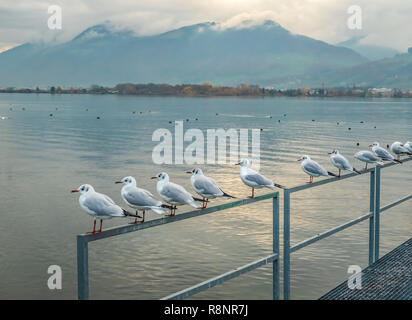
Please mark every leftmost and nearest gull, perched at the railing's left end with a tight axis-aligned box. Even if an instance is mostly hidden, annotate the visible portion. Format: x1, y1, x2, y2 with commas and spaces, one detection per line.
72, 184, 141, 234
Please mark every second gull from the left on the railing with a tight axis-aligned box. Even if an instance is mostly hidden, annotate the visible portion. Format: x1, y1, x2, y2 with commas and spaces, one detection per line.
115, 176, 171, 223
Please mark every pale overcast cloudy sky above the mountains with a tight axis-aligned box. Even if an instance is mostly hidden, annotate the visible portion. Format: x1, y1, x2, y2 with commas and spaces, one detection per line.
0, 0, 412, 52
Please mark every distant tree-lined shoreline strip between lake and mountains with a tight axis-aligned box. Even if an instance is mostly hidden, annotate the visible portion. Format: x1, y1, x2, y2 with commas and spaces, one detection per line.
0, 82, 412, 98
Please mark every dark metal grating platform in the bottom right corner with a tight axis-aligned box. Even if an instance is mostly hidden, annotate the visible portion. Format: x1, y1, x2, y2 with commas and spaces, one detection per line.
319, 238, 412, 300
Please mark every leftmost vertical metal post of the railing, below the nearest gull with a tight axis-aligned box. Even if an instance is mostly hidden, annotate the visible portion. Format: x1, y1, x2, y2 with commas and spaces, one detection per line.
77, 235, 89, 300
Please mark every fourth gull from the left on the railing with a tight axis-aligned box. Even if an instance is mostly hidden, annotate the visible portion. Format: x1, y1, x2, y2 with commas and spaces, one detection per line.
186, 168, 234, 209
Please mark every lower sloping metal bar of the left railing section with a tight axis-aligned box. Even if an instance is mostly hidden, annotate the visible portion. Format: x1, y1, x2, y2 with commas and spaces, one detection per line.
161, 253, 279, 300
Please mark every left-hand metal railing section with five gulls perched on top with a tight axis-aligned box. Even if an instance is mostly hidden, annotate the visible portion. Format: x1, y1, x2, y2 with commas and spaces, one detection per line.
77, 192, 280, 300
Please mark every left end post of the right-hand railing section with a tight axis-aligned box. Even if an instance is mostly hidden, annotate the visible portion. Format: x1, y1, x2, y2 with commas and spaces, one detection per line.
283, 189, 290, 300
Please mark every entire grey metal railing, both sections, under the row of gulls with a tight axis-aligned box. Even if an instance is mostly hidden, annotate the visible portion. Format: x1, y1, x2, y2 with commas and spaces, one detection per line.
77, 158, 412, 300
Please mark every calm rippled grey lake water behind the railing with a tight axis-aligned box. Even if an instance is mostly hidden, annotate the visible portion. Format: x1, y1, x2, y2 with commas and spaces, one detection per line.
0, 94, 412, 299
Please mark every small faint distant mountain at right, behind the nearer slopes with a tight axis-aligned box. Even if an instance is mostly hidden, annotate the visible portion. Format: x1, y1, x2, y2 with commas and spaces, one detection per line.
336, 36, 400, 60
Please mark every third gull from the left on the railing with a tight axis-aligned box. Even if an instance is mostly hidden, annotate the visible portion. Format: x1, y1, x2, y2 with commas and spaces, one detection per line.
152, 172, 203, 216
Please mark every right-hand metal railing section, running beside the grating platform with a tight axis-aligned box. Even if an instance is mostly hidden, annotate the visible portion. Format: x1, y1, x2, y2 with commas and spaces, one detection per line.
283, 158, 412, 300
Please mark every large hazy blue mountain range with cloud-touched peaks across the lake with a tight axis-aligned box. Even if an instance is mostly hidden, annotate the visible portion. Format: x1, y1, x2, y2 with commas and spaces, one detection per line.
0, 21, 368, 87
